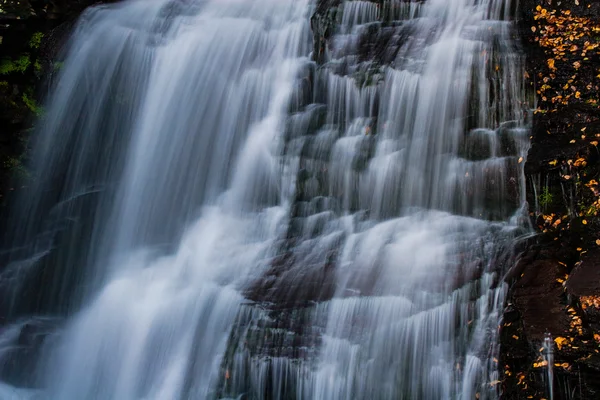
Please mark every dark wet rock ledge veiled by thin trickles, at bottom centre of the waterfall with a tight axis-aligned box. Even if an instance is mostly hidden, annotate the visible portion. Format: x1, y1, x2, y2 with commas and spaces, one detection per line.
217, 303, 326, 399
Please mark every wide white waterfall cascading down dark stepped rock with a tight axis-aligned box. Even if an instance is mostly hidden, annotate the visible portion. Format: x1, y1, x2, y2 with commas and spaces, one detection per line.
0, 0, 527, 400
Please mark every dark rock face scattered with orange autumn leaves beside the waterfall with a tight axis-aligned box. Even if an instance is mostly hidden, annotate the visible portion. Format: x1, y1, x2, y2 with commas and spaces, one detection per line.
500, 0, 600, 399
